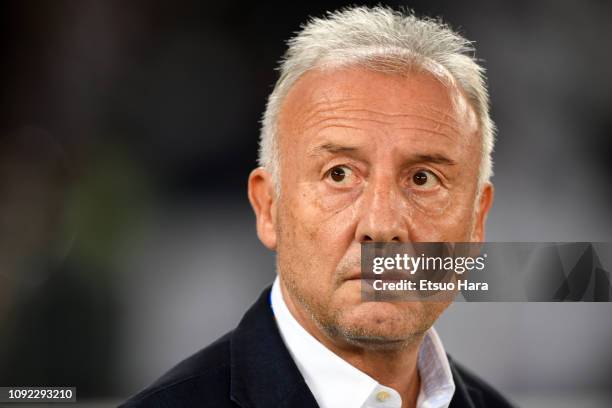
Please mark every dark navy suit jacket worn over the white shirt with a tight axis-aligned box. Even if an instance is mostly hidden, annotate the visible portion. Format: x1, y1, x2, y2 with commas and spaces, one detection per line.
122, 288, 511, 408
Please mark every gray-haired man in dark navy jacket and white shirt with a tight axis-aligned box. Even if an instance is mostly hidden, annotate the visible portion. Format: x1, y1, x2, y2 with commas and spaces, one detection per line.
125, 7, 509, 408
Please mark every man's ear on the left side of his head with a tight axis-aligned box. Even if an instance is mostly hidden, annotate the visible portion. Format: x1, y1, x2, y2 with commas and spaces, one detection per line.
249, 167, 276, 250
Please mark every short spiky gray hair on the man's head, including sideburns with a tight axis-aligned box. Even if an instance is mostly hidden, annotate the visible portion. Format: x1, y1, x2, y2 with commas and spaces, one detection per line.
258, 7, 495, 193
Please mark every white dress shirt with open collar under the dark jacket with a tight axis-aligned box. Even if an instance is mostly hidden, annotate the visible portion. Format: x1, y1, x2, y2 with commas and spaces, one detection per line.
270, 276, 455, 408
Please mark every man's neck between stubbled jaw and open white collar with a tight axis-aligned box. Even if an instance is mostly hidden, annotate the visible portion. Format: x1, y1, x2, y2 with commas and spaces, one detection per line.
280, 283, 423, 408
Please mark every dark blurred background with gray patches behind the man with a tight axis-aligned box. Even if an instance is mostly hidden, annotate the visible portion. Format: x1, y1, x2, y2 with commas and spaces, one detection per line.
0, 0, 612, 407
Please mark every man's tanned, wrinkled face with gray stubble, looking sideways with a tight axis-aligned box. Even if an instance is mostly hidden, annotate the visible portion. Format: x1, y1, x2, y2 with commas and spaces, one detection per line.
249, 68, 491, 344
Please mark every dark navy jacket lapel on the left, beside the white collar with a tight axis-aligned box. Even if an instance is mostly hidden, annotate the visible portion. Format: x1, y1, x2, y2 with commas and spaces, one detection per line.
230, 288, 318, 408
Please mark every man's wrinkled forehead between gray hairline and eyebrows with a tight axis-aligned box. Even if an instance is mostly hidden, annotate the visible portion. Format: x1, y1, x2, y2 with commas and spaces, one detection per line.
278, 67, 478, 146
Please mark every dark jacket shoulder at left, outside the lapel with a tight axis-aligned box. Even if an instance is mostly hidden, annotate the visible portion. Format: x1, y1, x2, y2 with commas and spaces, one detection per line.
121, 332, 233, 408
